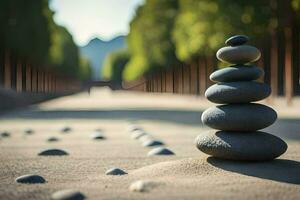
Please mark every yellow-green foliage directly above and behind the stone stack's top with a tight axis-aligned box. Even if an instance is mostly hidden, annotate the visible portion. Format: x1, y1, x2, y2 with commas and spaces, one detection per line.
173, 0, 272, 62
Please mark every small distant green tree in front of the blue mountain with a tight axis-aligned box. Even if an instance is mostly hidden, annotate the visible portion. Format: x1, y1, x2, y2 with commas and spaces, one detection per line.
102, 49, 130, 82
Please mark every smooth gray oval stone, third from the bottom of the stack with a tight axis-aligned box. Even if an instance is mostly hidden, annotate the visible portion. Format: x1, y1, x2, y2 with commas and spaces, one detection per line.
205, 81, 271, 104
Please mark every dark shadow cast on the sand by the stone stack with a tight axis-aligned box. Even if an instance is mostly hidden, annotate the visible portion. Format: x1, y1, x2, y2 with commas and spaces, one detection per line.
207, 157, 300, 185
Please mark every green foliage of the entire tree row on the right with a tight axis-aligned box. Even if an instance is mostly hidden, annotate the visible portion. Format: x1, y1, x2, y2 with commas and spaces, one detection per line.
104, 0, 300, 83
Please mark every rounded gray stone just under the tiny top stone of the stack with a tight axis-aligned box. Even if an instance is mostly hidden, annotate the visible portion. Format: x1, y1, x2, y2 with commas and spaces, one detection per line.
217, 45, 261, 64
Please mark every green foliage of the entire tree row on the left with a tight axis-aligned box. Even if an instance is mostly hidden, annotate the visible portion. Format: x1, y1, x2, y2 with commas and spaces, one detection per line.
0, 0, 91, 83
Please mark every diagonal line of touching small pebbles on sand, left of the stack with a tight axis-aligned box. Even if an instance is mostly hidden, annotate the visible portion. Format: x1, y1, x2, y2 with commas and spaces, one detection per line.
128, 124, 175, 156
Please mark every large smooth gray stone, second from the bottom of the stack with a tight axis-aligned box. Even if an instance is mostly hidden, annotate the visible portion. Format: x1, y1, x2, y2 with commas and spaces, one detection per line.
201, 103, 277, 131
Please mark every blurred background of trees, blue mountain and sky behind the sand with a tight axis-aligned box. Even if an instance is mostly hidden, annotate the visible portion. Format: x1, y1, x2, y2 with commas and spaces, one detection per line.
0, 0, 300, 108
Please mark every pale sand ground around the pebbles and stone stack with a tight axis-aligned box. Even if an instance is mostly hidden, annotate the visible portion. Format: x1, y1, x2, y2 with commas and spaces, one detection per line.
0, 89, 300, 200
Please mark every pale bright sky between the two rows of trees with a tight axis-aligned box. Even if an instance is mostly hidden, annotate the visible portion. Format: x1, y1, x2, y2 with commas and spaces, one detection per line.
50, 0, 144, 45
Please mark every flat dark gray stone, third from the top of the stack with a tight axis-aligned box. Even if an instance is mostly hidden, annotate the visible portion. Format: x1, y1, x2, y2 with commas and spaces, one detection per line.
209, 65, 264, 82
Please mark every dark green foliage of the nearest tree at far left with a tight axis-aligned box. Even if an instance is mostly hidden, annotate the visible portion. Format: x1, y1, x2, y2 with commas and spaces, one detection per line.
0, 0, 50, 63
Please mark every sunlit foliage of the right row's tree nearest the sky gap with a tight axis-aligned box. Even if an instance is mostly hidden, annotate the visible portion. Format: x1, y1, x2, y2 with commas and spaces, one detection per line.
124, 0, 178, 80
